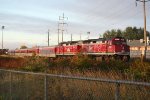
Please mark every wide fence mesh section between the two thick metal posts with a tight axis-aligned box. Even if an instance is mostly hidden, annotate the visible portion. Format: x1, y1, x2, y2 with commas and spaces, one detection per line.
47, 78, 114, 100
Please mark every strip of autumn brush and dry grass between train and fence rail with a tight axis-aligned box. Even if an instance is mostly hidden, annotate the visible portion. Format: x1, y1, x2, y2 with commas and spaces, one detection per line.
0, 55, 150, 82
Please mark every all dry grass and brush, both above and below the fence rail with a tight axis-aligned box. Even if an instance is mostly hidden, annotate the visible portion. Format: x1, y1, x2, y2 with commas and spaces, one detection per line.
0, 56, 150, 100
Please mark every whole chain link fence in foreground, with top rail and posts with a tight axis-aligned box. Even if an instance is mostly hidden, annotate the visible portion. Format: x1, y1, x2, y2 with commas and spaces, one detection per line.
0, 69, 150, 100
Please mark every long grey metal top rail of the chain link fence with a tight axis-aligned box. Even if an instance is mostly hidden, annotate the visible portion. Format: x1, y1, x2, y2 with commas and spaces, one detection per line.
0, 69, 150, 86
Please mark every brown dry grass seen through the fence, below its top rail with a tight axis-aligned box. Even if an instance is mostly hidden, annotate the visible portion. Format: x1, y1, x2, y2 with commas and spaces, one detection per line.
0, 73, 150, 100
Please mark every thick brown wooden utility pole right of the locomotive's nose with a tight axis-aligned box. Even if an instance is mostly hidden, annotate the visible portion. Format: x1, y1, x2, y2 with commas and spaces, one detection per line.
136, 0, 150, 60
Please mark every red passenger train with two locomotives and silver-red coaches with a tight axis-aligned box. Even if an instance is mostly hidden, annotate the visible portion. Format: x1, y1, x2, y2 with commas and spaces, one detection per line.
8, 37, 130, 61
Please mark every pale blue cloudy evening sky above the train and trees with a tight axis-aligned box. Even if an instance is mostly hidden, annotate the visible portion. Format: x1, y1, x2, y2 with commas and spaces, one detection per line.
0, 0, 150, 49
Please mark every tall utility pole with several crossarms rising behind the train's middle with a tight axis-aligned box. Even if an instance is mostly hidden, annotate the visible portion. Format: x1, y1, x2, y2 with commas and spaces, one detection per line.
59, 13, 68, 42
